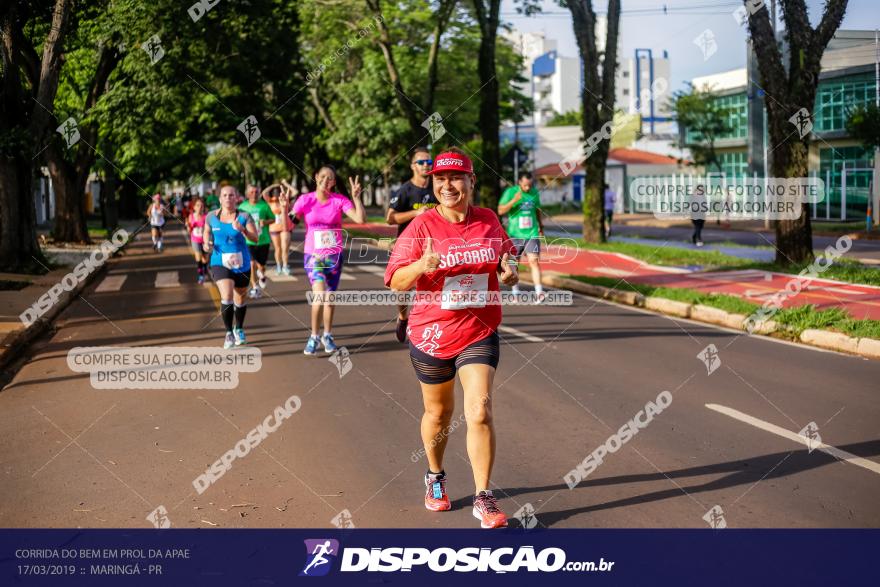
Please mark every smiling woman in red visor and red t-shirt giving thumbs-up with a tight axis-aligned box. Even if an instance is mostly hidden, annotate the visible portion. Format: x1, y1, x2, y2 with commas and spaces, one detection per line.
385, 149, 518, 528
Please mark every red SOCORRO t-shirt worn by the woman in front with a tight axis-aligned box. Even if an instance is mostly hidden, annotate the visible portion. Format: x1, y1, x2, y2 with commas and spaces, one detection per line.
385, 206, 516, 359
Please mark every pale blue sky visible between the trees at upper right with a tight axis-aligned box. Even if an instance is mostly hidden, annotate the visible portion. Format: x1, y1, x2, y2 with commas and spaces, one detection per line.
501, 0, 880, 89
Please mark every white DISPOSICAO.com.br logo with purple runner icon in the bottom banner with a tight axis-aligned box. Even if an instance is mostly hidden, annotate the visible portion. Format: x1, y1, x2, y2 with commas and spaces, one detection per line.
300, 539, 614, 577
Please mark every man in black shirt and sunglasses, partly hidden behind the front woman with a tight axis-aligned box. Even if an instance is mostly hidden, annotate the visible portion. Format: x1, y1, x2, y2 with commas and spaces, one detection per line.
385, 148, 437, 342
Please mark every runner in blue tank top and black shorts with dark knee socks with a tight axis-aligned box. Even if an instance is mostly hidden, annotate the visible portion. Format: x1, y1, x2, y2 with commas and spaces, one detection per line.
204, 185, 259, 349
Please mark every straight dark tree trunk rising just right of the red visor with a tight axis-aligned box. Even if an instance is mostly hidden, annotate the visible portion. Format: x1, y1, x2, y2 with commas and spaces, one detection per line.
473, 0, 501, 210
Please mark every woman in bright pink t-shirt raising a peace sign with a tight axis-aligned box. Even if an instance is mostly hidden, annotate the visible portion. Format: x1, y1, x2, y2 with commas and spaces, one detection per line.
293, 165, 367, 355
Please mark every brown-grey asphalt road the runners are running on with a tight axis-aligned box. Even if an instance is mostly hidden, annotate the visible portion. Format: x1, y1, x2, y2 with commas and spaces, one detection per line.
0, 227, 880, 528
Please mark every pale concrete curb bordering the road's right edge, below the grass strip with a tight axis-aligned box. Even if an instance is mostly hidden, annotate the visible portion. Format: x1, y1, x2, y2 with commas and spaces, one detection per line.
520, 273, 880, 359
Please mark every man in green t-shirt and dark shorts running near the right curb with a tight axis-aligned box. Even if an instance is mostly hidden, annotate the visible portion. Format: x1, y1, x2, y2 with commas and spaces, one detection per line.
498, 173, 544, 304
